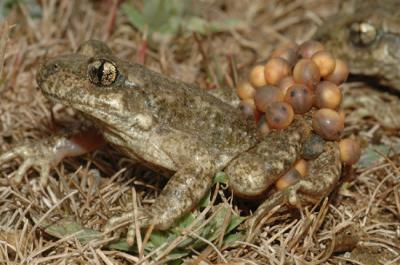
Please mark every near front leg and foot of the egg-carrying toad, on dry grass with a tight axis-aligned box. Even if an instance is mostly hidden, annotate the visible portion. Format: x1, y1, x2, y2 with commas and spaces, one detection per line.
104, 163, 214, 245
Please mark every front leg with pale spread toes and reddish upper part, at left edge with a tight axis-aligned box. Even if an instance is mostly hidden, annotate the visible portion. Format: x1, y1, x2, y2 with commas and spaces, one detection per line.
0, 130, 103, 186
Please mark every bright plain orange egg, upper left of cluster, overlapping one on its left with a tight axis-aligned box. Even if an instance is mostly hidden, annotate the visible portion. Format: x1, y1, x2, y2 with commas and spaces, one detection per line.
264, 57, 290, 85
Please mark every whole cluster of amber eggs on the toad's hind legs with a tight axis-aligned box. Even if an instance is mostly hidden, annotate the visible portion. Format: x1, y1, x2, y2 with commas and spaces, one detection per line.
236, 40, 360, 189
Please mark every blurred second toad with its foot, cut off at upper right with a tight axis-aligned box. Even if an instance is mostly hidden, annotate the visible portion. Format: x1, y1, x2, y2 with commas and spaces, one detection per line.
314, 0, 400, 130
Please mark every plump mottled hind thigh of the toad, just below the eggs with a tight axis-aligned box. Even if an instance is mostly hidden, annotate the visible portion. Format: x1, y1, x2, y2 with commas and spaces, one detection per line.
225, 117, 310, 198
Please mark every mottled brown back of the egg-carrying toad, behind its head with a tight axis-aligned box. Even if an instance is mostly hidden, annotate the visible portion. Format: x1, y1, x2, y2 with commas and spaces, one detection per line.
124, 61, 255, 152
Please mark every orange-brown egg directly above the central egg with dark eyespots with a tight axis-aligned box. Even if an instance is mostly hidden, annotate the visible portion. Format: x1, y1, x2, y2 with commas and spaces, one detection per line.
293, 59, 321, 89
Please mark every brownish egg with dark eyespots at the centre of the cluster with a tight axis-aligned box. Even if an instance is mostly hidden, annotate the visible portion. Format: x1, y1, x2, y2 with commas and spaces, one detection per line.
285, 84, 314, 114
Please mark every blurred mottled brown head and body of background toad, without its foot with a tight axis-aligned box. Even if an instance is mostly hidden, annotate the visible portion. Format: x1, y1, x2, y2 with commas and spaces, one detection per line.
314, 0, 400, 88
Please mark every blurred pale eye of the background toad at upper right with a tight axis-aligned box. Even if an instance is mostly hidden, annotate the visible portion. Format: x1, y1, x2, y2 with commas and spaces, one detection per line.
350, 22, 377, 47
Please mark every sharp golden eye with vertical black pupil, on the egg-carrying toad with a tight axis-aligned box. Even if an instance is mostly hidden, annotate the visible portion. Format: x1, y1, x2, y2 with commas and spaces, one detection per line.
87, 59, 118, 86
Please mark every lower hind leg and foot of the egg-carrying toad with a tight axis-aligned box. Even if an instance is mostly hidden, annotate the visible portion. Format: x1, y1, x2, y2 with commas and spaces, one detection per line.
245, 142, 341, 238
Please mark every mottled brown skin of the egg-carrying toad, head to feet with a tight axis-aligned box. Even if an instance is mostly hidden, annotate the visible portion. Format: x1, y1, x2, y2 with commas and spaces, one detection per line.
0, 41, 340, 243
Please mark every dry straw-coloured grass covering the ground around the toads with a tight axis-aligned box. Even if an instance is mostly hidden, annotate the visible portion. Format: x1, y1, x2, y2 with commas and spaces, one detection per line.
0, 0, 400, 265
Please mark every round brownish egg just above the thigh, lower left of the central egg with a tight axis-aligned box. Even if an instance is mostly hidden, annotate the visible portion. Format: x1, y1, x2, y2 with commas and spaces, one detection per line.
265, 102, 294, 129
